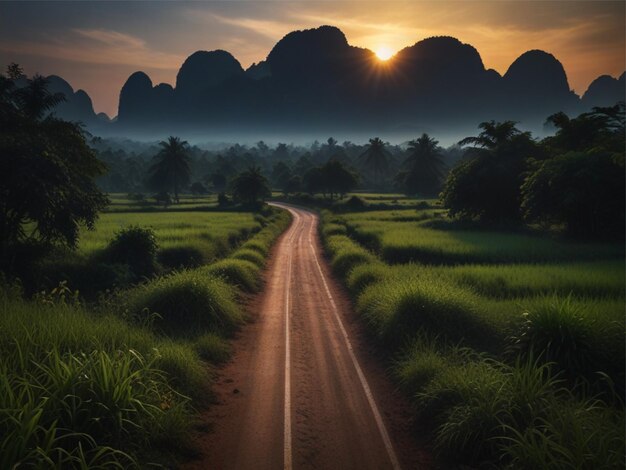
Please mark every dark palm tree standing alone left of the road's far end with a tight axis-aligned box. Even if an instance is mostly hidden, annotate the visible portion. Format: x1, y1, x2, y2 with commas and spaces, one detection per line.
149, 136, 191, 202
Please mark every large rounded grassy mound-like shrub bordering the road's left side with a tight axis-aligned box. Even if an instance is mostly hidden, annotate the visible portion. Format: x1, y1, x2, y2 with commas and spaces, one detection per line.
127, 271, 243, 333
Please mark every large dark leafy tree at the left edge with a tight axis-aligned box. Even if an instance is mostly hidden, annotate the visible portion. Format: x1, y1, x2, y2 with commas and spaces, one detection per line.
0, 70, 107, 265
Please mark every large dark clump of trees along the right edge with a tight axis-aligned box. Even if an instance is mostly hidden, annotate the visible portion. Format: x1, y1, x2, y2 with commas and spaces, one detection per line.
441, 103, 625, 238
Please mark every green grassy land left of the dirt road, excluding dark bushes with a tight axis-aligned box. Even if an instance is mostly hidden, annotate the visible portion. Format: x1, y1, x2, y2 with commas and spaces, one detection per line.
0, 197, 289, 468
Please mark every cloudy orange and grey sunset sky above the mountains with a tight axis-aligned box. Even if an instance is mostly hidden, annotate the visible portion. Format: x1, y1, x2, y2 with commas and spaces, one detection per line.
0, 0, 626, 117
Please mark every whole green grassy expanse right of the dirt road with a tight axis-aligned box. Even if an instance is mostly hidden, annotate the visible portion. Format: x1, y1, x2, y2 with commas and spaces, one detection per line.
321, 200, 625, 468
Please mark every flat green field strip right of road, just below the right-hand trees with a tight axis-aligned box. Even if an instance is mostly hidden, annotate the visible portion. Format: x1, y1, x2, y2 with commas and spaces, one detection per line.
338, 210, 624, 264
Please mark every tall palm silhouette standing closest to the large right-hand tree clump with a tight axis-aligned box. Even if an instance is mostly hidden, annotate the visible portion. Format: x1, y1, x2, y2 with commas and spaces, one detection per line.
404, 134, 446, 196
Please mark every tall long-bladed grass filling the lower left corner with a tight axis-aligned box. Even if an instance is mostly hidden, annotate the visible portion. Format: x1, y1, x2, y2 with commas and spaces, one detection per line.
0, 295, 197, 468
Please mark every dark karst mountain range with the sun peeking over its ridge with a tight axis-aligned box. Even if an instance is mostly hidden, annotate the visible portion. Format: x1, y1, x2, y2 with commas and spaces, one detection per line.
94, 26, 624, 137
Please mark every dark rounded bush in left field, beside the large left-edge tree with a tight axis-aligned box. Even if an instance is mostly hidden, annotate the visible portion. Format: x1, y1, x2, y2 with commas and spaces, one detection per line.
104, 226, 158, 276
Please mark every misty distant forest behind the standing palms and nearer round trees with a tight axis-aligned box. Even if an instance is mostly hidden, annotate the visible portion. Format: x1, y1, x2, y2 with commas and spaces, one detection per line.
90, 137, 465, 197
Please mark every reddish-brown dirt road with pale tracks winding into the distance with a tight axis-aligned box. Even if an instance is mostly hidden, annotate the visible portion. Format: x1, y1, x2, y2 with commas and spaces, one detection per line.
188, 204, 420, 470
